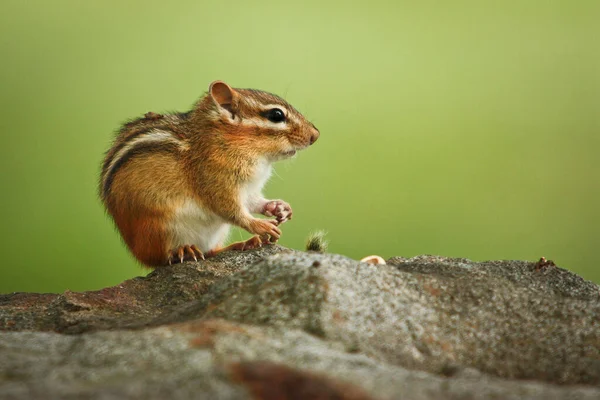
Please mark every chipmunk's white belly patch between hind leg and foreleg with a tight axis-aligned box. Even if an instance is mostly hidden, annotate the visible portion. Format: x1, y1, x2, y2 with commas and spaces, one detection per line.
170, 199, 230, 252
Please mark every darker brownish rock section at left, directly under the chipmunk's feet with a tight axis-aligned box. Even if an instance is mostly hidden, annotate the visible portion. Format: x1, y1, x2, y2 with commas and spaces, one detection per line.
0, 246, 290, 333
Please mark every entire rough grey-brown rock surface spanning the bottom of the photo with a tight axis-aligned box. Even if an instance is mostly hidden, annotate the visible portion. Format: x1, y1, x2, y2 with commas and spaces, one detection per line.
0, 246, 600, 399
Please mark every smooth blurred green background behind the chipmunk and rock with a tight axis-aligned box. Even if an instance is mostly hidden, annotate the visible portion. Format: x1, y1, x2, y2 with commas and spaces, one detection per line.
0, 0, 600, 292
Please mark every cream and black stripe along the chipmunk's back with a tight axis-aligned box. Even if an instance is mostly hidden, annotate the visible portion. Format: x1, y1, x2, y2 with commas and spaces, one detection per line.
102, 130, 181, 198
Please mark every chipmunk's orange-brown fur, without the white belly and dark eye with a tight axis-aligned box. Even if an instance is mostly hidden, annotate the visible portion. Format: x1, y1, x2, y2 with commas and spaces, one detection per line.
100, 82, 319, 266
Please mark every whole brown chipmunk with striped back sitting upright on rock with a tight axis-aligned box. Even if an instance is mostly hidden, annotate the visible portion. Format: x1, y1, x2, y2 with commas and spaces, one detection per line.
100, 81, 319, 267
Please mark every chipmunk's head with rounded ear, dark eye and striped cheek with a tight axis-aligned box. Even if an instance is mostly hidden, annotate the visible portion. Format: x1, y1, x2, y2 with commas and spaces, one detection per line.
197, 81, 319, 160
